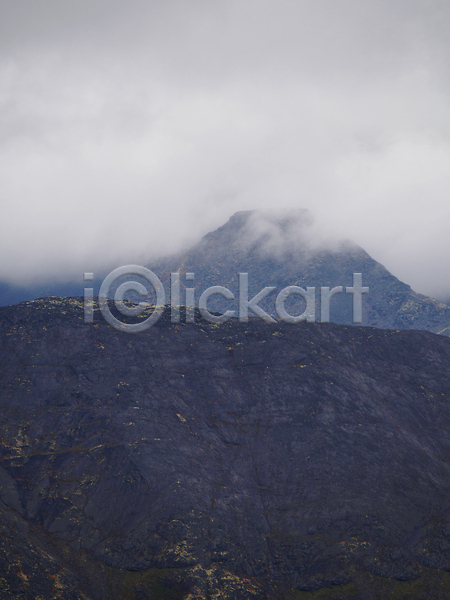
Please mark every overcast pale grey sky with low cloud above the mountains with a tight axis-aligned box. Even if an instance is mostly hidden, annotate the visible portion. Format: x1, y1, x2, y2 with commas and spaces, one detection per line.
0, 0, 450, 299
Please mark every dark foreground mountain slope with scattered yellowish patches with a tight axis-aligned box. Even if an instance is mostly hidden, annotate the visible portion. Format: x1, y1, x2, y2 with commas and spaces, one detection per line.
0, 298, 450, 600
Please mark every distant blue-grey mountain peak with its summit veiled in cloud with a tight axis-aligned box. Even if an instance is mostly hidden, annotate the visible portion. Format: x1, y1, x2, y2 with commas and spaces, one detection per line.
150, 211, 450, 335
